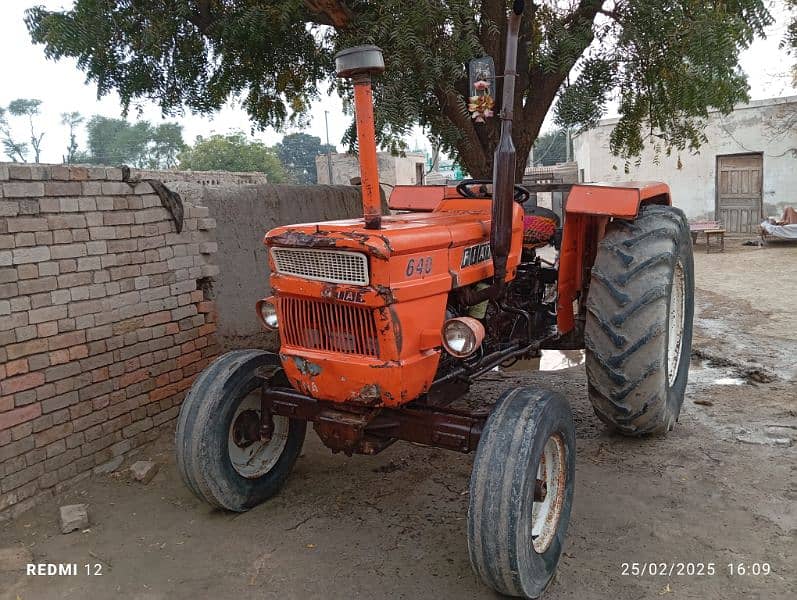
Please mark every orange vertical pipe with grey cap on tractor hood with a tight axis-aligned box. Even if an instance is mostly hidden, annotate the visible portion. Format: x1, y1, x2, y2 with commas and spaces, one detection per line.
335, 45, 386, 230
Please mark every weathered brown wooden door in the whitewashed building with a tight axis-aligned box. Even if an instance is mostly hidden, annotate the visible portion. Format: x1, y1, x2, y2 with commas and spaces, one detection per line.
716, 154, 763, 233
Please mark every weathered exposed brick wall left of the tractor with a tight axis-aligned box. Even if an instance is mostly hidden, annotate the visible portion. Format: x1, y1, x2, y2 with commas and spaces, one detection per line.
0, 164, 218, 518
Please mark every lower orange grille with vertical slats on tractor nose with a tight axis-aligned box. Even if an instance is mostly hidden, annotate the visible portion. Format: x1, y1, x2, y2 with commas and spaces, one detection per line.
277, 297, 379, 357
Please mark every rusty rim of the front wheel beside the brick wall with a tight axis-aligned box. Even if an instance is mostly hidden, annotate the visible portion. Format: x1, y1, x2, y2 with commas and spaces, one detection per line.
227, 392, 289, 479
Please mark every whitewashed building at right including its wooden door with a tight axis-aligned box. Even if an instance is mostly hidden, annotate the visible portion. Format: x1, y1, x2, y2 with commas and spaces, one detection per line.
574, 96, 797, 233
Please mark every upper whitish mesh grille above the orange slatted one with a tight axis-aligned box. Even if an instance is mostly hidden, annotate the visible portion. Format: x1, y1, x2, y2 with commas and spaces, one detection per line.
271, 248, 368, 285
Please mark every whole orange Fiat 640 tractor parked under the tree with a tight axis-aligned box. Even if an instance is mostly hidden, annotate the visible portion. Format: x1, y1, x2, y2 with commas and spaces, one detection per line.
176, 2, 694, 598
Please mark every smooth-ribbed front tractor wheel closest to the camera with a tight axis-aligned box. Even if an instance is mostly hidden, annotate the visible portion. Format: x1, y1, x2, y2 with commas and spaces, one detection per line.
468, 387, 576, 598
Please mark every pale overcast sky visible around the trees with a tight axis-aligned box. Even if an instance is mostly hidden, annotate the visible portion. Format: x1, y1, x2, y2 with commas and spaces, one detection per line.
0, 0, 797, 163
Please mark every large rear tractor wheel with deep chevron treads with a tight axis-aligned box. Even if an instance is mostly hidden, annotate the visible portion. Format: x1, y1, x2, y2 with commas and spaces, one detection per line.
584, 205, 694, 436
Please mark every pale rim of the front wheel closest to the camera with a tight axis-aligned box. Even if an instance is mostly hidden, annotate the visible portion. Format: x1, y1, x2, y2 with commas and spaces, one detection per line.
531, 433, 567, 554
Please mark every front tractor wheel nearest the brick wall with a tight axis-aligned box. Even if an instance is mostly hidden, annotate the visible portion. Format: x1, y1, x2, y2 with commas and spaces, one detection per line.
175, 350, 307, 512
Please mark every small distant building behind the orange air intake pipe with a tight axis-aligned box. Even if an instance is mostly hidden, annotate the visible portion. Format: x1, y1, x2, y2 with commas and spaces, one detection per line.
315, 152, 426, 186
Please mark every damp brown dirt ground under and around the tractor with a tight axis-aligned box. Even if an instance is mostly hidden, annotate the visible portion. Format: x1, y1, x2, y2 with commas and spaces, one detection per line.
0, 240, 797, 600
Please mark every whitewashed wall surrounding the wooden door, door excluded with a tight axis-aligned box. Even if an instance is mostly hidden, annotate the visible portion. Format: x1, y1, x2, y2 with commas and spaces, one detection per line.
574, 96, 797, 218
